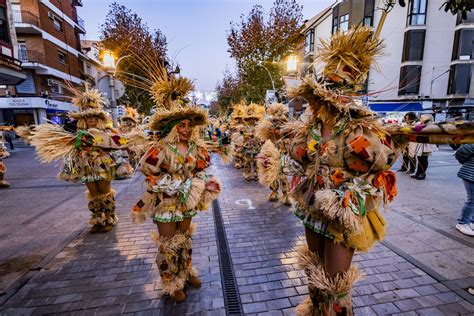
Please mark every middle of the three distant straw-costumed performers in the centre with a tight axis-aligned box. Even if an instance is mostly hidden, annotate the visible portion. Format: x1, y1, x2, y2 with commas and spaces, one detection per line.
242, 103, 265, 181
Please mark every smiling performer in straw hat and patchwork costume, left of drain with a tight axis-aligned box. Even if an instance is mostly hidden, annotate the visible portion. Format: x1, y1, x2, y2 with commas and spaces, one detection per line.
131, 59, 227, 302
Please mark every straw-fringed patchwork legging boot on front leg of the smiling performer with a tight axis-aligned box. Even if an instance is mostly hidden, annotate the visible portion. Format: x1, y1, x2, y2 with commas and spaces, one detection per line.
151, 232, 187, 303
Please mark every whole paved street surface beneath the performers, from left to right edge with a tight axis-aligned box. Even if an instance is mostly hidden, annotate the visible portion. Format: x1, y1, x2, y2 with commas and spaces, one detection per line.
0, 144, 474, 315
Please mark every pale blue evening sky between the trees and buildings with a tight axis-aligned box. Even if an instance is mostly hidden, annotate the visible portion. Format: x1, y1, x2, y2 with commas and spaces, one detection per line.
78, 0, 334, 91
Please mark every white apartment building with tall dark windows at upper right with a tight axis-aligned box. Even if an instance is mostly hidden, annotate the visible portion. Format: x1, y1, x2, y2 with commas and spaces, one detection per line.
300, 0, 474, 118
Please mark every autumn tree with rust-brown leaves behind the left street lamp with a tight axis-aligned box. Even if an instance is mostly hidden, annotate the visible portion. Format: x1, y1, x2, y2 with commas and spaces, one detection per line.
100, 2, 167, 114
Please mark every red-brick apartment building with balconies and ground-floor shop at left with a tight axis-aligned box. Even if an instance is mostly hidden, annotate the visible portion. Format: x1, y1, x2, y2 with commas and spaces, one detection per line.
0, 0, 84, 125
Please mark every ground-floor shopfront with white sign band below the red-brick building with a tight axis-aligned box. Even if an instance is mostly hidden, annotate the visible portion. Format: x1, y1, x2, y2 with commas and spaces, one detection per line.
0, 97, 78, 126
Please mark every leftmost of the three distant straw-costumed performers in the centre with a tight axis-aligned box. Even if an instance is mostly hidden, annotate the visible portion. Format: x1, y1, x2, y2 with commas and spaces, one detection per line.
230, 102, 247, 169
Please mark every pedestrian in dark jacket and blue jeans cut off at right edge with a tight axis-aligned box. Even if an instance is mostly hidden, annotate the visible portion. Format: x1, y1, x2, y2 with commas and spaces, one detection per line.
454, 144, 474, 236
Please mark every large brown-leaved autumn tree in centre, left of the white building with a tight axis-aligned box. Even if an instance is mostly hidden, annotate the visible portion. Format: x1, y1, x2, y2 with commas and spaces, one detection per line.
227, 0, 303, 102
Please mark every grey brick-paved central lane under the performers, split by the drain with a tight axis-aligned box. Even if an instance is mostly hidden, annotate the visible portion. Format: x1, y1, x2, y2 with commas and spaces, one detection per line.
0, 157, 474, 315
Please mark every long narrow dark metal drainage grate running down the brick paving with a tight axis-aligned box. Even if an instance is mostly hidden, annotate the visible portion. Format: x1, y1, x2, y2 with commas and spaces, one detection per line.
212, 200, 243, 315
